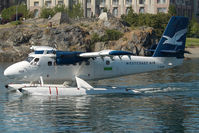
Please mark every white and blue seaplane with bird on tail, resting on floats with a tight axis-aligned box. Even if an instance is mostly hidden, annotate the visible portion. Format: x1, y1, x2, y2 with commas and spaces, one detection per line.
4, 16, 189, 96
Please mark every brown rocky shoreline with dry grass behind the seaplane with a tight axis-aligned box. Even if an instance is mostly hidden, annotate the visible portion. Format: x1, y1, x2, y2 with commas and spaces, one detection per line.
0, 18, 199, 62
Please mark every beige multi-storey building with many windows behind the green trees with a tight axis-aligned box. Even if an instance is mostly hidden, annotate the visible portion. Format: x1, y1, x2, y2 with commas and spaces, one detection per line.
27, 0, 194, 17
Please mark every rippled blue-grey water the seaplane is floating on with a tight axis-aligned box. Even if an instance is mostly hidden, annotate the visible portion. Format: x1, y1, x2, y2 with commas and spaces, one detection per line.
0, 59, 199, 133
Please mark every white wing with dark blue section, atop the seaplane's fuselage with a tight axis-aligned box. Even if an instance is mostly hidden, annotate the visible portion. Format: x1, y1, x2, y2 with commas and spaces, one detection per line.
79, 50, 133, 58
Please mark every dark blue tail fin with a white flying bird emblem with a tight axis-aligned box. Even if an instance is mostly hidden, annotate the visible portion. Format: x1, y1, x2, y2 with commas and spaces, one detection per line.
153, 16, 189, 58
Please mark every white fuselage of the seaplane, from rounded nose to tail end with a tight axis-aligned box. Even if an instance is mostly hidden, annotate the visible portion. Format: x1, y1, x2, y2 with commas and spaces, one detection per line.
4, 54, 183, 81
